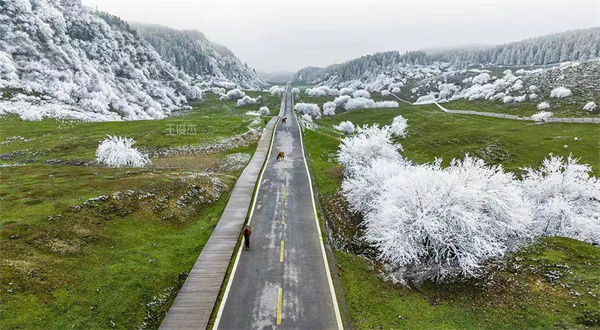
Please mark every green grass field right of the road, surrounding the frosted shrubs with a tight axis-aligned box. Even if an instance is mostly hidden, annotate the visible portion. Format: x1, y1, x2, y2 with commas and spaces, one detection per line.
301, 102, 600, 329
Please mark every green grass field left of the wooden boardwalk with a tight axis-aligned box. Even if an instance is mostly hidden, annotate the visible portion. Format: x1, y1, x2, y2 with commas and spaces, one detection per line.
0, 93, 280, 329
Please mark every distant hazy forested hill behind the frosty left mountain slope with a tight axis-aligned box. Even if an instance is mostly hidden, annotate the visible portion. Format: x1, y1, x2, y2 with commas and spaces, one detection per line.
132, 23, 266, 89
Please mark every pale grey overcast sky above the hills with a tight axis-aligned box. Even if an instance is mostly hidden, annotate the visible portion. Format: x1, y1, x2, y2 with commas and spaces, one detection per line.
83, 0, 600, 71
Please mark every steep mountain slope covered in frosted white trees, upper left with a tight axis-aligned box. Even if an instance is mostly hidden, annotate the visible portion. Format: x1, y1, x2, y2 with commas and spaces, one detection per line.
0, 0, 201, 120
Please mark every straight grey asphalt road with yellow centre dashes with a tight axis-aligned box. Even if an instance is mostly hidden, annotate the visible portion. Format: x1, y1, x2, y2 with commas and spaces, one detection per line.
215, 86, 341, 329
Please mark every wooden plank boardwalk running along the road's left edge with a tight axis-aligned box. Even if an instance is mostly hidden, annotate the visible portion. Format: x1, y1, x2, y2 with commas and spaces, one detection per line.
160, 117, 278, 329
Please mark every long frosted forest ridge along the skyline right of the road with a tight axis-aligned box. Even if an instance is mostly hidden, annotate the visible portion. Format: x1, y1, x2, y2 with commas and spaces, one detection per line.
294, 28, 600, 84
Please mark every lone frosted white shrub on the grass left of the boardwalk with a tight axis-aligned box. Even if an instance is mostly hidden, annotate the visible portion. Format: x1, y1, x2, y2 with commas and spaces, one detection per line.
96, 135, 150, 167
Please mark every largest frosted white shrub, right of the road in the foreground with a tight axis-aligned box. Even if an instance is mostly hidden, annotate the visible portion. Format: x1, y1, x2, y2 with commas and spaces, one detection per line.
356, 155, 530, 280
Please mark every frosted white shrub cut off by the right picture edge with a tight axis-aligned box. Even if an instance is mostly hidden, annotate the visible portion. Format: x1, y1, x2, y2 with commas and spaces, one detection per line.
523, 155, 600, 244
